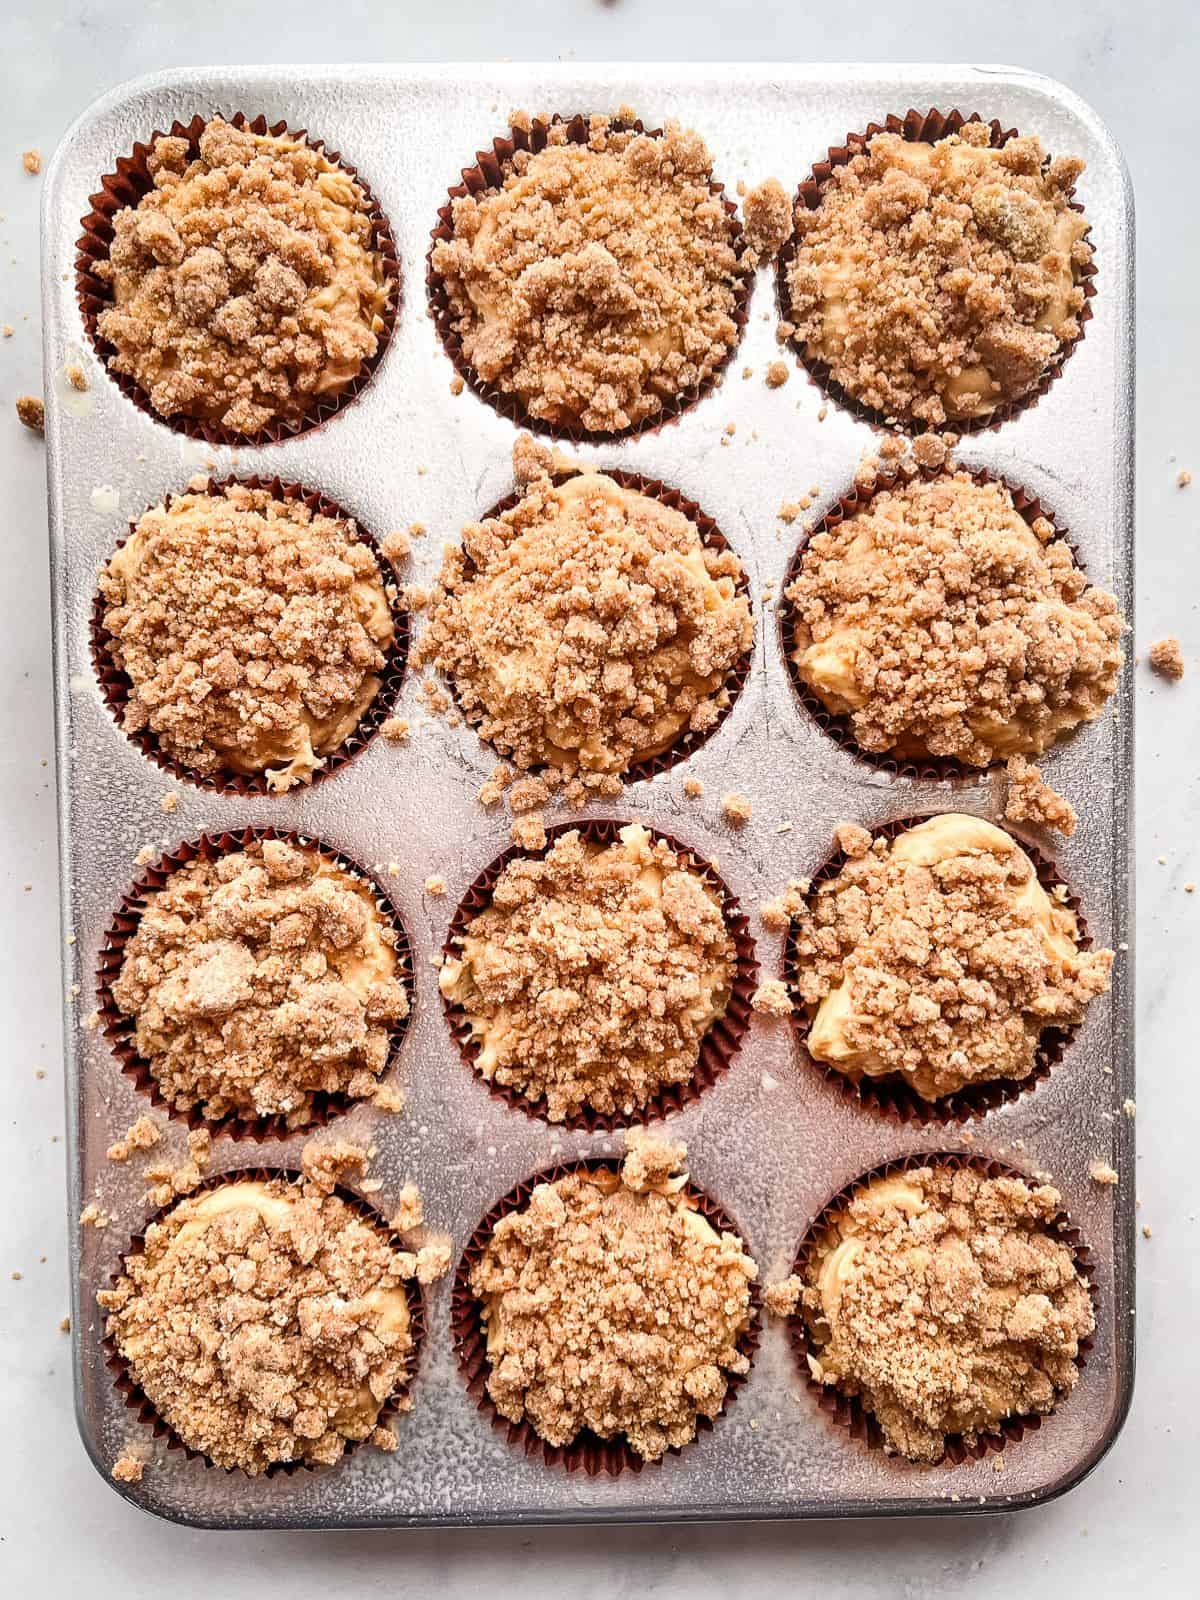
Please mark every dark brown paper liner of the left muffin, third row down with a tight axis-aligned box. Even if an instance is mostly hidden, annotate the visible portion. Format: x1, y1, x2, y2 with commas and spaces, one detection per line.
96, 827, 416, 1144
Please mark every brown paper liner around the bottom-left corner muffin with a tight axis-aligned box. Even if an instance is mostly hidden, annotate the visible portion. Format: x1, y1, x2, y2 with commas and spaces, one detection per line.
101, 1166, 426, 1478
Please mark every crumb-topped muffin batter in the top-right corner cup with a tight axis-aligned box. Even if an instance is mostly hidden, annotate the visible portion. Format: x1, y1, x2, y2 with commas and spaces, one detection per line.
787, 123, 1091, 424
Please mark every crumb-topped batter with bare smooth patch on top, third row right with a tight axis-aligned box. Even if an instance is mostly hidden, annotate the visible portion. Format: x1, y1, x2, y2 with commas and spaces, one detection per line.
789, 813, 1112, 1099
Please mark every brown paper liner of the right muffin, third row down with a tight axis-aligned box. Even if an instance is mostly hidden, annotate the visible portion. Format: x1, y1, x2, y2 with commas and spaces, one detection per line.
784, 811, 1091, 1128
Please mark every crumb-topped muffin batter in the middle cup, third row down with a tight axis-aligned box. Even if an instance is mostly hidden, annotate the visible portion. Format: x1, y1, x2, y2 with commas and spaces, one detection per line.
438, 824, 736, 1122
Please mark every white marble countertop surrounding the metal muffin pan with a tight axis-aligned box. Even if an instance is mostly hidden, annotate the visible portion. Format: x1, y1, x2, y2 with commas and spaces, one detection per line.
0, 0, 1200, 1600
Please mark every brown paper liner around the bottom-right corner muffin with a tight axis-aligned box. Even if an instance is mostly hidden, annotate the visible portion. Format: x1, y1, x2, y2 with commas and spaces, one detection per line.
787, 1150, 1098, 1466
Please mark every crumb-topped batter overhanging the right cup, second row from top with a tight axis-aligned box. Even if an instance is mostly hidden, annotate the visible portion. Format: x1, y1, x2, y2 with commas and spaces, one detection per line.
787, 472, 1125, 766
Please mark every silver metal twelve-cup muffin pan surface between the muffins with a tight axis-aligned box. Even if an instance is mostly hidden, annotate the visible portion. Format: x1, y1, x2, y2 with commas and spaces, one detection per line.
43, 64, 1134, 1528
